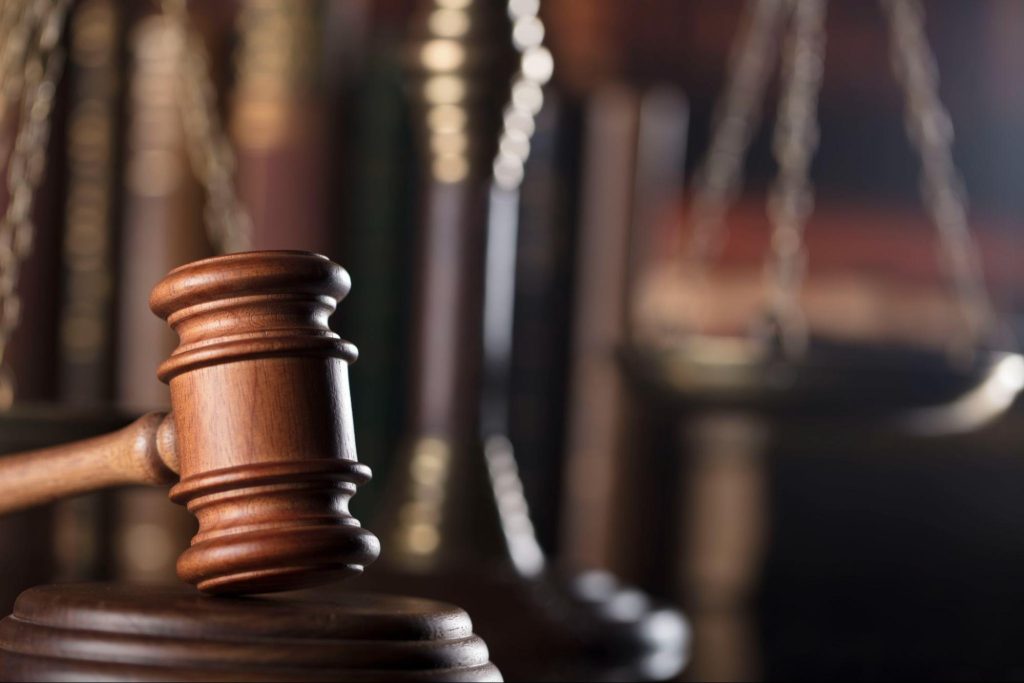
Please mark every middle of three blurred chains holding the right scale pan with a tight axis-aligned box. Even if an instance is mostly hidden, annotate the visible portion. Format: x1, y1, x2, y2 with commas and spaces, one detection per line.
763, 0, 827, 358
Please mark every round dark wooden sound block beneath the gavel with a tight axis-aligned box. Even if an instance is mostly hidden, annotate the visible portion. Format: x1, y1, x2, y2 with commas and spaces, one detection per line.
0, 584, 502, 681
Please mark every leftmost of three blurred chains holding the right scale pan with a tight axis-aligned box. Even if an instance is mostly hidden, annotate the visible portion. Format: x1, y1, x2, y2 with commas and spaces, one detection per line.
683, 0, 783, 274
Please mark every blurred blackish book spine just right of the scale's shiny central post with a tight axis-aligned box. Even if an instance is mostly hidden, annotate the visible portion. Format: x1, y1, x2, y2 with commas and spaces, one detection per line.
509, 93, 577, 552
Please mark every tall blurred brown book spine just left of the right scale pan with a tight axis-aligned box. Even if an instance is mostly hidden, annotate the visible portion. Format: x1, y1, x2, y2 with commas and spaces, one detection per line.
562, 84, 640, 569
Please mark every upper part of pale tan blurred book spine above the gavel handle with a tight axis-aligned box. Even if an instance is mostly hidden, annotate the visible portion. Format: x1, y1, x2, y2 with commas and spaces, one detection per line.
118, 9, 206, 411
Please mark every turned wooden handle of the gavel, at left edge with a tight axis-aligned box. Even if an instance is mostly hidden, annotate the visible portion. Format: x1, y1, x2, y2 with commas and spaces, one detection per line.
0, 413, 178, 514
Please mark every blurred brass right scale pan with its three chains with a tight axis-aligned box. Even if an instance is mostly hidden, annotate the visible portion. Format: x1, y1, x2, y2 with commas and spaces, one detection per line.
628, 0, 1024, 423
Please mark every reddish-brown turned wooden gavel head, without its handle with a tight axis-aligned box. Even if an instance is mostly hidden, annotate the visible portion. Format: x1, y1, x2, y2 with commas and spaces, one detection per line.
150, 252, 380, 594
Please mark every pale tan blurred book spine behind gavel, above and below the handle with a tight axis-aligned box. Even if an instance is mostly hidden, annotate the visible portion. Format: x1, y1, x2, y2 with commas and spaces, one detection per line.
115, 14, 200, 582
